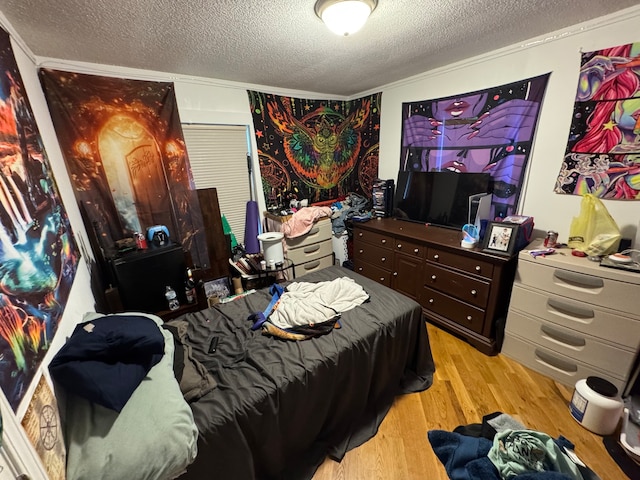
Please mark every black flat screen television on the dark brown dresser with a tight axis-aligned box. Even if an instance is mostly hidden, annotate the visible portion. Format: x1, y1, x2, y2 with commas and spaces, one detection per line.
393, 171, 492, 229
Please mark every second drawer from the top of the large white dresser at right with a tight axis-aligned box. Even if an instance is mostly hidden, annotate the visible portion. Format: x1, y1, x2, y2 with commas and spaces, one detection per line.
507, 283, 640, 351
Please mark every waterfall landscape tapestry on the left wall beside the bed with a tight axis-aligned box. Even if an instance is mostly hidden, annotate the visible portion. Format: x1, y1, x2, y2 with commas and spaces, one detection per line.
0, 30, 80, 410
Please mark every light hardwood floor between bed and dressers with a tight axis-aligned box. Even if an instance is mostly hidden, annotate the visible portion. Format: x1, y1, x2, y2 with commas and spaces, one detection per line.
313, 324, 627, 480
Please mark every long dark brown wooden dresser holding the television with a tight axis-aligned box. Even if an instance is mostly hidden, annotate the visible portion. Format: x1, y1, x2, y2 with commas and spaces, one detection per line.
353, 218, 517, 355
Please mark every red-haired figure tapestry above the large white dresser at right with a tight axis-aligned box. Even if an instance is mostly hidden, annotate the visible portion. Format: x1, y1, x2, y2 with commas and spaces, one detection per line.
555, 43, 640, 200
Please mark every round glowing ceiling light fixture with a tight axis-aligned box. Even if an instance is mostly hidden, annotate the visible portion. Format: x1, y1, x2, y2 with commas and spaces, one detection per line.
315, 0, 378, 37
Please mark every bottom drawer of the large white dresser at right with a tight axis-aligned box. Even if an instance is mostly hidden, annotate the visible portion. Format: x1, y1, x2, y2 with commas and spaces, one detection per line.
502, 334, 626, 392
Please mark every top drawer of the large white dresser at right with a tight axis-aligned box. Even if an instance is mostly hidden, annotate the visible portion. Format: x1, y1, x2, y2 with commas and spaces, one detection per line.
516, 254, 640, 312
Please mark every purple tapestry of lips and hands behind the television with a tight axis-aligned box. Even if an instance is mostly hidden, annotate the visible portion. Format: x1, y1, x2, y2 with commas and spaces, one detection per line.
400, 74, 549, 218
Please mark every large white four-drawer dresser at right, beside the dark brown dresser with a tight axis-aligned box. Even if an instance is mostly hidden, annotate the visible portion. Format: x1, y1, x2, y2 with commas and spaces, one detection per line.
502, 241, 640, 391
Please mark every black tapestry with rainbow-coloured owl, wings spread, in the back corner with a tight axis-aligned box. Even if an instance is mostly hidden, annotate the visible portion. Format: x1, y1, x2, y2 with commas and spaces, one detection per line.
248, 91, 381, 207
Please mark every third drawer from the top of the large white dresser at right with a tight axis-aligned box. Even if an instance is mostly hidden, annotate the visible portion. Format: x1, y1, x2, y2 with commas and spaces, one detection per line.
505, 310, 635, 378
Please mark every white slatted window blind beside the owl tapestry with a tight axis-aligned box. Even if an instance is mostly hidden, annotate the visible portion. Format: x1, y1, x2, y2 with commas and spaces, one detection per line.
182, 124, 250, 243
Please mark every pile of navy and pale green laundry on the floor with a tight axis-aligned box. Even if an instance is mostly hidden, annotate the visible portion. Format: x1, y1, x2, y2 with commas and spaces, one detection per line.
427, 412, 600, 480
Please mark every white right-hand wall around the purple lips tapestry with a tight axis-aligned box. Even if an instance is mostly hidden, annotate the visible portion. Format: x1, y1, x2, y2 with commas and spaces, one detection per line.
379, 7, 640, 248
